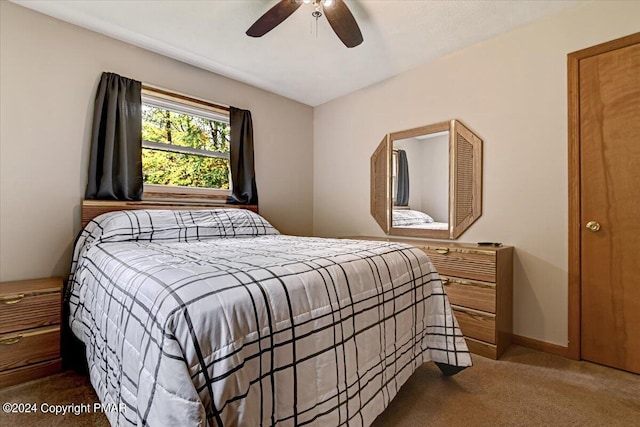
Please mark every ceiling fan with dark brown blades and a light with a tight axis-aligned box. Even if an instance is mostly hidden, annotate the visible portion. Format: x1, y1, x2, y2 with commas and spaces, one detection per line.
247, 0, 363, 47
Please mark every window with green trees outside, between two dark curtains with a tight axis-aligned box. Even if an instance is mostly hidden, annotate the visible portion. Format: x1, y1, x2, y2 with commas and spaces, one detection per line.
142, 88, 231, 198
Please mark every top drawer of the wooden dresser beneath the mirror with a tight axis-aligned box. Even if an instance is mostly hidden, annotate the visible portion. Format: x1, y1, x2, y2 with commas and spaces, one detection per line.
421, 246, 496, 283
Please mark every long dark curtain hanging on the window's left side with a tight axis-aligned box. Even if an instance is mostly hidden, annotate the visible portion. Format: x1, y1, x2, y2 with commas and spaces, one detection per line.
85, 73, 142, 200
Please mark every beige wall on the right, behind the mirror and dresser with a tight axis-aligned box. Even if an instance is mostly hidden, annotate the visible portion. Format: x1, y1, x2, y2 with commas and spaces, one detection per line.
314, 1, 640, 346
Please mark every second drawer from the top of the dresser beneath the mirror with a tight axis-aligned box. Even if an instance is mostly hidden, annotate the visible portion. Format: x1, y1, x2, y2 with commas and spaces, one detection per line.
441, 276, 496, 313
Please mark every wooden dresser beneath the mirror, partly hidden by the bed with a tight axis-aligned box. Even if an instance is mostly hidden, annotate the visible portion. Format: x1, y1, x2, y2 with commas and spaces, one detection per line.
353, 237, 513, 359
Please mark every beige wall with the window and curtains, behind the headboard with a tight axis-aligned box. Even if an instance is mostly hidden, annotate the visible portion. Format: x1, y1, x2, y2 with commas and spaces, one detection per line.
0, 0, 313, 280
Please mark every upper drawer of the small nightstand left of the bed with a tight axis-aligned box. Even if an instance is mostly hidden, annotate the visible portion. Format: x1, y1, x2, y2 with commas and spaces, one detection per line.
0, 289, 62, 334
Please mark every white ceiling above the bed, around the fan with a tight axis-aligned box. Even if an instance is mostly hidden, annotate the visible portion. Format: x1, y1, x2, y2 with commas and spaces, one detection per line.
13, 0, 583, 106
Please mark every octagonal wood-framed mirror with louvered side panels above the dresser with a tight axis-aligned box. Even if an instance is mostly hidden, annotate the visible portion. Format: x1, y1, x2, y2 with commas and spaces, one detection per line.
371, 120, 482, 239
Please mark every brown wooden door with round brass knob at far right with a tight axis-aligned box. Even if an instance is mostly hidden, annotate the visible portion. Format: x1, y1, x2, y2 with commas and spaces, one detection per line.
575, 34, 640, 373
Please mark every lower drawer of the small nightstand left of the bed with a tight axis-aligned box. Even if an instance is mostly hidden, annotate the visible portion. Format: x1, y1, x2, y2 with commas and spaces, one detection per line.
0, 326, 60, 370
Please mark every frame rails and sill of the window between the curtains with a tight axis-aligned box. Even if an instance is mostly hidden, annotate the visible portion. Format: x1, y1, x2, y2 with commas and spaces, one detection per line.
141, 84, 233, 201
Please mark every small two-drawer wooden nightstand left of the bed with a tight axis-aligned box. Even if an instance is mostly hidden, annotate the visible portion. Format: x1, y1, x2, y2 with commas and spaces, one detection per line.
0, 278, 62, 388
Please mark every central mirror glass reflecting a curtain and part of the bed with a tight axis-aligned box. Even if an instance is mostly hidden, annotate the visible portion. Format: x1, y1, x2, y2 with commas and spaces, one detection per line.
391, 131, 449, 230
